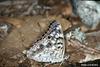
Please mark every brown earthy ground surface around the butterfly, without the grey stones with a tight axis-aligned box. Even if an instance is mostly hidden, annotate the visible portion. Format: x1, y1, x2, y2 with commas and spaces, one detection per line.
0, 0, 100, 67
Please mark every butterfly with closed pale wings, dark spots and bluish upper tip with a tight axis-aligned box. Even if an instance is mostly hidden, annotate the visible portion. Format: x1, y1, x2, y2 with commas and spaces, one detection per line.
26, 20, 68, 63
